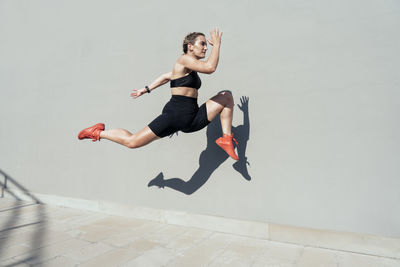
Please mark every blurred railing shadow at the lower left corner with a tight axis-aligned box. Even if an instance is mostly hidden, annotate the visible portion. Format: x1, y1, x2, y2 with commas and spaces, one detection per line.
0, 169, 47, 267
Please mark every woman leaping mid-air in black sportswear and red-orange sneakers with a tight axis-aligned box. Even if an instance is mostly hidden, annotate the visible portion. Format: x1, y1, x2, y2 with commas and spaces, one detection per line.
78, 29, 238, 160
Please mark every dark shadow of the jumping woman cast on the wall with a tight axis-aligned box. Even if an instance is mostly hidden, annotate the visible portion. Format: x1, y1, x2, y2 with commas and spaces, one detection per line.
148, 96, 251, 195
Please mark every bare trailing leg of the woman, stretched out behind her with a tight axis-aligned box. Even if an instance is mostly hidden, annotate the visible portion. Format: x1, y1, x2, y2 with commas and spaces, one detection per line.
100, 126, 160, 148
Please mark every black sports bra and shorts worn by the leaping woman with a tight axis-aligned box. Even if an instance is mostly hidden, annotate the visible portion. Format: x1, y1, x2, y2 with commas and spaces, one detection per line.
149, 71, 210, 137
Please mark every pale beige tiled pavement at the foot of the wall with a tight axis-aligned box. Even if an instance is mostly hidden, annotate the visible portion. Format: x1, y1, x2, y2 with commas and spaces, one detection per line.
0, 198, 400, 267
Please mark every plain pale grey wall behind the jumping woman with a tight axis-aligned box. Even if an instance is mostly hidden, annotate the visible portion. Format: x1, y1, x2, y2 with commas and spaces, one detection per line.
0, 0, 400, 237
